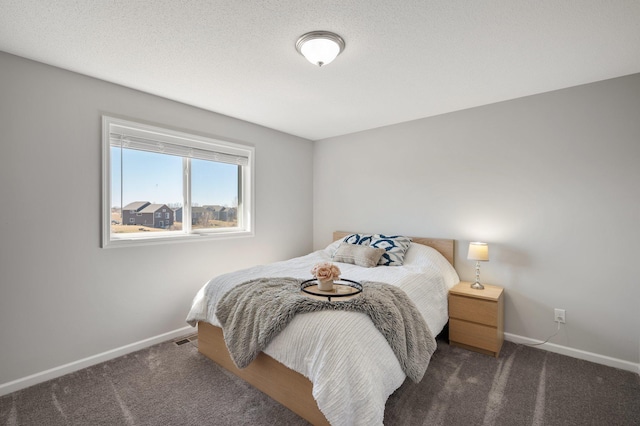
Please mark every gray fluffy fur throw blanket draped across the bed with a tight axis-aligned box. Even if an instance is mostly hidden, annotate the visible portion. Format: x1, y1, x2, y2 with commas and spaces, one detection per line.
216, 278, 436, 383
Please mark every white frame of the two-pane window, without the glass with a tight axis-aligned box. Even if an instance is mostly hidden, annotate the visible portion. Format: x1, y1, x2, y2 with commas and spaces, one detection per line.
102, 115, 255, 248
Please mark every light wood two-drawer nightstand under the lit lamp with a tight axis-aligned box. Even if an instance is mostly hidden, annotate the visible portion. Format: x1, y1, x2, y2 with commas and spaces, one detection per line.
449, 281, 504, 358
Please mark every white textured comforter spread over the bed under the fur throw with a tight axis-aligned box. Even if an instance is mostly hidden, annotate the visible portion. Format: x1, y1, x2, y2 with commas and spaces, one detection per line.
187, 241, 460, 426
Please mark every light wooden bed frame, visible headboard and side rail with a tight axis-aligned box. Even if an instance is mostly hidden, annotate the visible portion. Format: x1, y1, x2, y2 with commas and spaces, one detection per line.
198, 232, 454, 425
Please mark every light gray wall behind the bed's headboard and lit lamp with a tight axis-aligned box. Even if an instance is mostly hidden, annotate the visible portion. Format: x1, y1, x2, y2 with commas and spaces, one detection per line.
314, 74, 640, 367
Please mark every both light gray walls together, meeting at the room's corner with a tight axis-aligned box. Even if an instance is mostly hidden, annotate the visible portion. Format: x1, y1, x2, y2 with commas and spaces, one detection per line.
0, 48, 640, 392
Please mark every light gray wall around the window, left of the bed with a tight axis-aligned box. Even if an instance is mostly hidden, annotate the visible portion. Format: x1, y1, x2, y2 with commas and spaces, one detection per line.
0, 52, 313, 385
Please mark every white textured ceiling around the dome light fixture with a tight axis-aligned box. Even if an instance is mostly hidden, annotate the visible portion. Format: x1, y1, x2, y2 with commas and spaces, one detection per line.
0, 0, 640, 140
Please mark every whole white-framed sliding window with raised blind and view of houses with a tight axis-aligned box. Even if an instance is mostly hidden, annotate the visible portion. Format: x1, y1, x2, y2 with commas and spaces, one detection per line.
102, 116, 254, 247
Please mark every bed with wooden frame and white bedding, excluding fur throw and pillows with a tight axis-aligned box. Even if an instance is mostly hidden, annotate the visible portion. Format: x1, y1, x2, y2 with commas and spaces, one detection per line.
187, 232, 459, 425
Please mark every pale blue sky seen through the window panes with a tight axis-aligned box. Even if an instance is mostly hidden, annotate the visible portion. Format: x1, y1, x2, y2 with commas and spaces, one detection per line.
111, 147, 238, 207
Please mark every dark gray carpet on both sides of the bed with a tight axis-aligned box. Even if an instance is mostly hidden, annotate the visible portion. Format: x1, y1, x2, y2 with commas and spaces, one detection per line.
0, 334, 640, 426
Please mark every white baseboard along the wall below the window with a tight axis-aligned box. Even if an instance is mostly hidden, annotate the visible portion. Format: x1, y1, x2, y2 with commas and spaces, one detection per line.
0, 326, 195, 396
